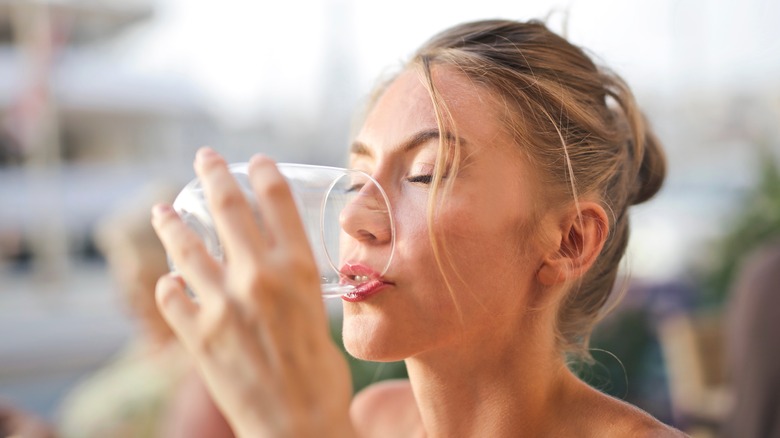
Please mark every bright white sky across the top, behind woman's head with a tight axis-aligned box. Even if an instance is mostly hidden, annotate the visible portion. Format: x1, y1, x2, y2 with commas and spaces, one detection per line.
116, 0, 780, 122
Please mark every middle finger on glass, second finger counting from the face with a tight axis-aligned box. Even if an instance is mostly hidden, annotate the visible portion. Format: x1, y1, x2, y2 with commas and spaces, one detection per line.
195, 148, 265, 260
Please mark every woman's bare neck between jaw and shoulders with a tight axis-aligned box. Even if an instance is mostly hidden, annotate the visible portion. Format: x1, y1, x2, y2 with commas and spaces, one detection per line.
406, 314, 576, 437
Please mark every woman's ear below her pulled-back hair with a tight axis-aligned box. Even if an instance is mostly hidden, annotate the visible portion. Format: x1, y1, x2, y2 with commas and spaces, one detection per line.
537, 201, 609, 286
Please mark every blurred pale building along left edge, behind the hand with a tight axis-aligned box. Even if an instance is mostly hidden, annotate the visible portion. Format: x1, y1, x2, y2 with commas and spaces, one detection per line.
0, 0, 222, 416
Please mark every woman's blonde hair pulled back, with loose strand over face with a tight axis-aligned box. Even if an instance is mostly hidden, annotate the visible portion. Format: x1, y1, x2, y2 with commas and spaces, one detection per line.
366, 20, 666, 360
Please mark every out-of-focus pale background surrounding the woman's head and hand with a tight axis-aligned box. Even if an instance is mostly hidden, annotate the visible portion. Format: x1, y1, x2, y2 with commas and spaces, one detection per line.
0, 0, 780, 436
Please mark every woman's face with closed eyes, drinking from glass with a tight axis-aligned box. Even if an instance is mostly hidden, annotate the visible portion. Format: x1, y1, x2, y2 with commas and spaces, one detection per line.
343, 68, 541, 360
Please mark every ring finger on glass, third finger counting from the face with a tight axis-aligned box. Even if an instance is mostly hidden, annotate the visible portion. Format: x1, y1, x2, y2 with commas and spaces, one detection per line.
152, 204, 223, 302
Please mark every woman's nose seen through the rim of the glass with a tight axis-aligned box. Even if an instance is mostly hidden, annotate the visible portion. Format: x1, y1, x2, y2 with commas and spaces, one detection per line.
339, 182, 393, 245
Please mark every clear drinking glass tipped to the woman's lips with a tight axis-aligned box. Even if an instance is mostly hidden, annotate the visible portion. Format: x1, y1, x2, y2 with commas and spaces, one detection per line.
170, 163, 395, 298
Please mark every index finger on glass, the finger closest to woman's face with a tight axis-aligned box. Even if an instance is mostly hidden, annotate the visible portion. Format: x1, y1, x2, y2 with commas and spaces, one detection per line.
249, 155, 309, 255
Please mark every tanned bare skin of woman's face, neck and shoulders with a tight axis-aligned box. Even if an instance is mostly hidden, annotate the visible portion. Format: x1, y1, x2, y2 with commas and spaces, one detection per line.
343, 67, 681, 437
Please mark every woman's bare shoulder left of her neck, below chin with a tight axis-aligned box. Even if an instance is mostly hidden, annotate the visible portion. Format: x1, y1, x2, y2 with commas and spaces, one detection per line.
350, 379, 423, 438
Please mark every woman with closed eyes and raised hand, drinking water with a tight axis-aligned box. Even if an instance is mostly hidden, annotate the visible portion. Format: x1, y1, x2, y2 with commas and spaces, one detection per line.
153, 20, 680, 437
